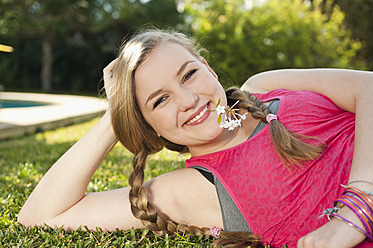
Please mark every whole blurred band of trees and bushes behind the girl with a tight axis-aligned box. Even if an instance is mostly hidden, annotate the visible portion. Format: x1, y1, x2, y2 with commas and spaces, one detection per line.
0, 0, 373, 94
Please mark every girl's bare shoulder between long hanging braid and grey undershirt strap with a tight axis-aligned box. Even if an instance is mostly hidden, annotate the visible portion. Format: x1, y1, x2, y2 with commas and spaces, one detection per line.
145, 168, 222, 227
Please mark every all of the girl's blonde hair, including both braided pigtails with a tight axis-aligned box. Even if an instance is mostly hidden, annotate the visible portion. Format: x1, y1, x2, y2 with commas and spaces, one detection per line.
108, 30, 322, 247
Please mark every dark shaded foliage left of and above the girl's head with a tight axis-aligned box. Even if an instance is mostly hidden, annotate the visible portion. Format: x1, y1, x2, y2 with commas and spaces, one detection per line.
0, 0, 182, 93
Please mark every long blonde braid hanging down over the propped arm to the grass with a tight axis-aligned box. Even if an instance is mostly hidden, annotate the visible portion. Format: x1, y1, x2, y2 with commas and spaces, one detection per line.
129, 148, 210, 237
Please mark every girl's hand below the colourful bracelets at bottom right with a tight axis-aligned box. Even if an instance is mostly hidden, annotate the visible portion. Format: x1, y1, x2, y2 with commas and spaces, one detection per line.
297, 207, 366, 248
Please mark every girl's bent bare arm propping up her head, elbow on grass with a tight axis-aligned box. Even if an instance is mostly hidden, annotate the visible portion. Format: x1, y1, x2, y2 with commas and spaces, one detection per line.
18, 61, 222, 231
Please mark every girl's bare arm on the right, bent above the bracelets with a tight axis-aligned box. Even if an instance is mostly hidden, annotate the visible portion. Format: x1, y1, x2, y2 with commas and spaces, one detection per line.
242, 69, 373, 178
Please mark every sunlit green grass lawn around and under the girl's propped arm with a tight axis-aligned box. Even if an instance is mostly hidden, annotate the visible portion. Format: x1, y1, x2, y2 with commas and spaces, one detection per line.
0, 119, 212, 247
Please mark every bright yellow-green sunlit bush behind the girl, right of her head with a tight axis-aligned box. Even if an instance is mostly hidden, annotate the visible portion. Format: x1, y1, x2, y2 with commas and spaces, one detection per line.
187, 0, 361, 86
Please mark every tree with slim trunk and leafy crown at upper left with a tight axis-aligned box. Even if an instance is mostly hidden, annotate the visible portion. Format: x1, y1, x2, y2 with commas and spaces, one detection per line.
0, 0, 115, 92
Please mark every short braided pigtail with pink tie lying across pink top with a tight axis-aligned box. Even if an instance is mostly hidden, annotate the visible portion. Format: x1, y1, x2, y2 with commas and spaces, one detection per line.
226, 88, 324, 169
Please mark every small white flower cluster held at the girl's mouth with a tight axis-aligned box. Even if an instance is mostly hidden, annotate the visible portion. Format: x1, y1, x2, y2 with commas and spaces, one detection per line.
210, 99, 247, 131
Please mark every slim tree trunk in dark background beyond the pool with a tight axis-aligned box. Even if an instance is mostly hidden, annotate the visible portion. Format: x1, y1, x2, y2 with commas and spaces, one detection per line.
41, 33, 53, 93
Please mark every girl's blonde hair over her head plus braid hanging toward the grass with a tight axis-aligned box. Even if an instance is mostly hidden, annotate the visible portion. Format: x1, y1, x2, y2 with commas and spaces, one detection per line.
108, 30, 209, 236
